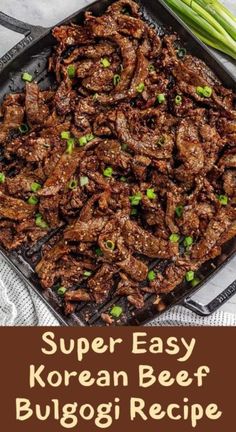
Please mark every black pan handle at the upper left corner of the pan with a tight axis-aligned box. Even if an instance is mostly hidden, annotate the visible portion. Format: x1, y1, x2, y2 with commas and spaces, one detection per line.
0, 11, 49, 72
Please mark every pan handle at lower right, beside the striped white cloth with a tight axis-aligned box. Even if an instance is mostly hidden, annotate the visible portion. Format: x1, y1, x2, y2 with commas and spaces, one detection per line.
182, 280, 236, 316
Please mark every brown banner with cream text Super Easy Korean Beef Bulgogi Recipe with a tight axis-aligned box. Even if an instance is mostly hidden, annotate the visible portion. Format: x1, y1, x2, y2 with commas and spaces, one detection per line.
0, 327, 236, 432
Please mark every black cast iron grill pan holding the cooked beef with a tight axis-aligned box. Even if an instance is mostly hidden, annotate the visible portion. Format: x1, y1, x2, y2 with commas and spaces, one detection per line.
0, 0, 236, 326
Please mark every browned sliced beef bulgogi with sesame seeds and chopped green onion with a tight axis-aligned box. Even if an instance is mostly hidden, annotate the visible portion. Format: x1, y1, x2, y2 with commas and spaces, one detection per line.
0, 0, 236, 322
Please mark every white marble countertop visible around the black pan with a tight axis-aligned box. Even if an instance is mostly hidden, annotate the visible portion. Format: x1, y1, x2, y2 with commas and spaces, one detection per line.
0, 0, 236, 313
